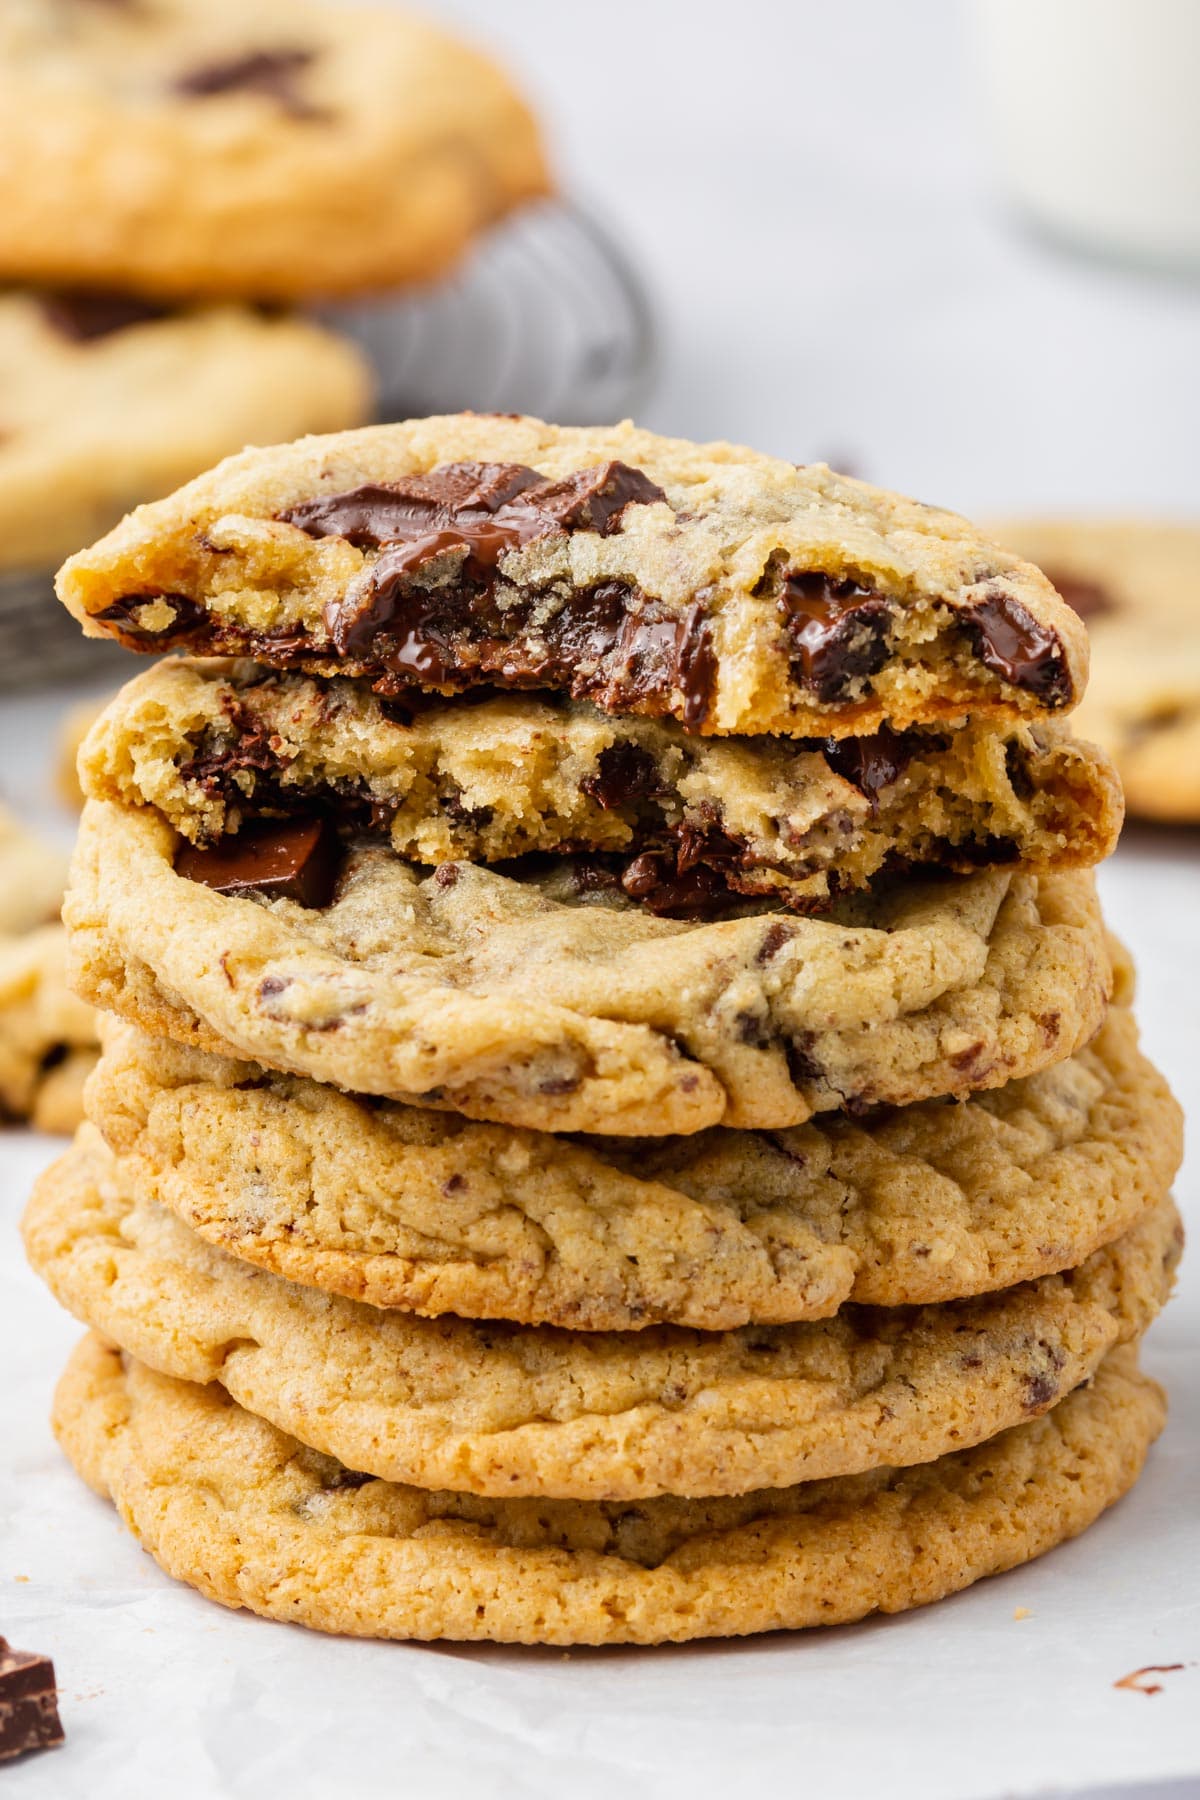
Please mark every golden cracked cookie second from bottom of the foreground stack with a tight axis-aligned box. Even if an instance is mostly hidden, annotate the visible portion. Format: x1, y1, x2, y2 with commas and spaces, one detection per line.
23, 1125, 1182, 1499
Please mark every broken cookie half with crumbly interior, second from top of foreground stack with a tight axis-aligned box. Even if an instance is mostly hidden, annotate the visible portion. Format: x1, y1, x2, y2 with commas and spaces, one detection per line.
81, 659, 1121, 918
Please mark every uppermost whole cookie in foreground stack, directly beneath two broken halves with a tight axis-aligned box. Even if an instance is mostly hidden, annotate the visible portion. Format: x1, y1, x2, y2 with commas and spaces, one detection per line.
63, 801, 1112, 1136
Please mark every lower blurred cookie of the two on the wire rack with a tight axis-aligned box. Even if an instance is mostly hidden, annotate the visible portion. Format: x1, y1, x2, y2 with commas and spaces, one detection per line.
0, 293, 372, 571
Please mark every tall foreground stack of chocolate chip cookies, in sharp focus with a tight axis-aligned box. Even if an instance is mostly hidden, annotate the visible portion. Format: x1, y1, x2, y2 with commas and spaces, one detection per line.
25, 416, 1180, 1643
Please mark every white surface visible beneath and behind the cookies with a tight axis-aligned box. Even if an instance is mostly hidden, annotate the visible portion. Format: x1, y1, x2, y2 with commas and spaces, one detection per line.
0, 0, 1200, 1800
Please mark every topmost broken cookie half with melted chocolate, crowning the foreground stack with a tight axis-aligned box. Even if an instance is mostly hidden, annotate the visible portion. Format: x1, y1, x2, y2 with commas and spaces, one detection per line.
59, 414, 1087, 738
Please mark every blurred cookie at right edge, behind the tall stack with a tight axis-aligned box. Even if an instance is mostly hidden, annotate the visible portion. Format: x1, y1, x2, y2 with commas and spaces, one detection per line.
990, 518, 1200, 824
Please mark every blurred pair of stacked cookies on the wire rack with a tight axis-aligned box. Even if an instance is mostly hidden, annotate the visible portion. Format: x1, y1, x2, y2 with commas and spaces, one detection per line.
0, 0, 547, 680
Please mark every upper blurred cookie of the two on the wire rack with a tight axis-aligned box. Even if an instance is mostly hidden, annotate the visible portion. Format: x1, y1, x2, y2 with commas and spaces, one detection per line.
0, 0, 549, 301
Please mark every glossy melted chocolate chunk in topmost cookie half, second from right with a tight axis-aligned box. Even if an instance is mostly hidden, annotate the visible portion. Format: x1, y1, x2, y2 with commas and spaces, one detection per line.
777, 571, 894, 704
